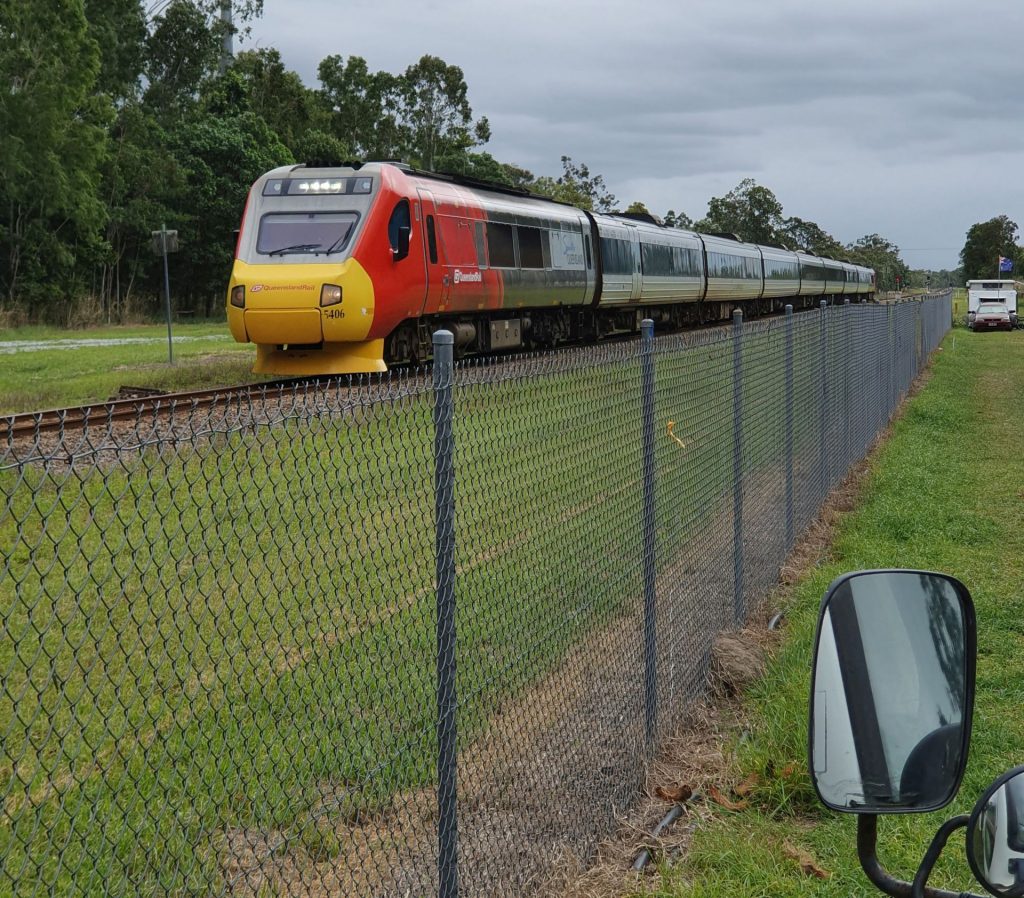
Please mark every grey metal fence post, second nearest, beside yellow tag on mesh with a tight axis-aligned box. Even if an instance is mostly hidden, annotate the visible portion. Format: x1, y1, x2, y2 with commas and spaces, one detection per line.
640, 318, 657, 747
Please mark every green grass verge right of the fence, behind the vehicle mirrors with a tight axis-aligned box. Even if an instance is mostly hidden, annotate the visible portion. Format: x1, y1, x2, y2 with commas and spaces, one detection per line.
643, 332, 1024, 898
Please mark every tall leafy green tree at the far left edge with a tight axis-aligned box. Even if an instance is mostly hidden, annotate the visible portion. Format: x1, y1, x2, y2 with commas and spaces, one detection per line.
0, 0, 112, 301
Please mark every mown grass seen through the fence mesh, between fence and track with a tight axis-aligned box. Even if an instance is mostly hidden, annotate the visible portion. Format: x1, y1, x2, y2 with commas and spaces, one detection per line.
0, 307, 942, 896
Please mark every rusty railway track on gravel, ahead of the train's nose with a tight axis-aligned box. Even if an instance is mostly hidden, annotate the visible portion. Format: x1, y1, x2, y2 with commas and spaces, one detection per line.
0, 377, 316, 442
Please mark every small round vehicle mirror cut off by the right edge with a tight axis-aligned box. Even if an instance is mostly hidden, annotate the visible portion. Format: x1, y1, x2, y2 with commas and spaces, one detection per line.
967, 770, 1024, 896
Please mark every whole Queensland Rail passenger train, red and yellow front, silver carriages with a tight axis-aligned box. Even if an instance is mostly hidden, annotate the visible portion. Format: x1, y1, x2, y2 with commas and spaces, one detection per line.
227, 163, 874, 375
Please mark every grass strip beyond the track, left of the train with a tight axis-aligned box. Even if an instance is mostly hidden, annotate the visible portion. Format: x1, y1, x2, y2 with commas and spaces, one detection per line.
0, 322, 260, 415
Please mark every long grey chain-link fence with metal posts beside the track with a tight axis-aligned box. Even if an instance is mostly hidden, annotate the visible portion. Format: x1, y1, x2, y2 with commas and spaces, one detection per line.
0, 295, 951, 898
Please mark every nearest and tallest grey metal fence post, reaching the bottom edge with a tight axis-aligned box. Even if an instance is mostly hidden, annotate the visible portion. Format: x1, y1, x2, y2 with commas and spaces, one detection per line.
433, 331, 459, 898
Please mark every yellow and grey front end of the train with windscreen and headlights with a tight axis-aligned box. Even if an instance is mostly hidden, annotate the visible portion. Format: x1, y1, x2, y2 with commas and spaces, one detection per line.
227, 166, 395, 375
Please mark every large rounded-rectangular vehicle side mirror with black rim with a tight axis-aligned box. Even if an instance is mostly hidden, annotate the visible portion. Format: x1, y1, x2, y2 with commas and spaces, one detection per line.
810, 570, 974, 814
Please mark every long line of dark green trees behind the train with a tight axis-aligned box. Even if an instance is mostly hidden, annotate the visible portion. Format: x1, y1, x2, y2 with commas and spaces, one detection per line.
0, 0, 958, 325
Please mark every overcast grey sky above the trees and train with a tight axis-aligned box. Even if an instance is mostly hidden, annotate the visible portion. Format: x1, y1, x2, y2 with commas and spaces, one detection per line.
245, 0, 1024, 268
